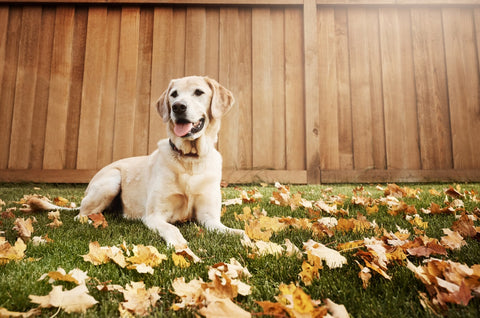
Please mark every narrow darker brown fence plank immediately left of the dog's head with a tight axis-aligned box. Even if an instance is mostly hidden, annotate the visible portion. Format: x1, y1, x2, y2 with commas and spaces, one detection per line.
133, 8, 153, 156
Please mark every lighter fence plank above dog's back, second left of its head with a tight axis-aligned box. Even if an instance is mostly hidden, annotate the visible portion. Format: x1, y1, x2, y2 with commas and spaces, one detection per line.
113, 7, 140, 160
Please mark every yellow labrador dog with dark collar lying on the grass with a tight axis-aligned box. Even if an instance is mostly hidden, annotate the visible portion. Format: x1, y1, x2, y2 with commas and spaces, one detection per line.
78, 76, 244, 249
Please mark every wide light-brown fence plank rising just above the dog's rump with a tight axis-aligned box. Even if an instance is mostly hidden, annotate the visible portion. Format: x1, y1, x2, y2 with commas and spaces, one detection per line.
77, 7, 108, 169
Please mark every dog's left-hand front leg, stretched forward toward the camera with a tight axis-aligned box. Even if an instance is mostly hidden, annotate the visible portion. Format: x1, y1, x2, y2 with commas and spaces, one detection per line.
142, 213, 188, 250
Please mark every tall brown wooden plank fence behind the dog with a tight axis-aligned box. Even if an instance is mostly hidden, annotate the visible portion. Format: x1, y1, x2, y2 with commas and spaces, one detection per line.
0, 0, 480, 183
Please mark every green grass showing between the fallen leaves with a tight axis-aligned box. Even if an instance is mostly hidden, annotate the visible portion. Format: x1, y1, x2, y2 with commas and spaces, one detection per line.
0, 184, 480, 317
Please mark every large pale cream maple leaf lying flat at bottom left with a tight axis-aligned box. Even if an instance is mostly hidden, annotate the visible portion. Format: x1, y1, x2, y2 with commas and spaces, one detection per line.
28, 285, 98, 313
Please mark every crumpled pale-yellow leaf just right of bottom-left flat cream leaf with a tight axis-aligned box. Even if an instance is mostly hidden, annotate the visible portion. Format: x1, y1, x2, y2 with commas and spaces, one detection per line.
119, 282, 160, 316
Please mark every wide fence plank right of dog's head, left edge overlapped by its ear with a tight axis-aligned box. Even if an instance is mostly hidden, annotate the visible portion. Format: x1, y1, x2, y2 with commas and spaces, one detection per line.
218, 8, 253, 169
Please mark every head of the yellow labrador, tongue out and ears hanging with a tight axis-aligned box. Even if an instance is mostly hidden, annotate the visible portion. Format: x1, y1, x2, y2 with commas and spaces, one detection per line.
157, 76, 234, 140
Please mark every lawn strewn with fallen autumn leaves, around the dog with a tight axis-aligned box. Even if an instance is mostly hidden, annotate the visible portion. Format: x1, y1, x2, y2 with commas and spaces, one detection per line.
0, 184, 480, 317
